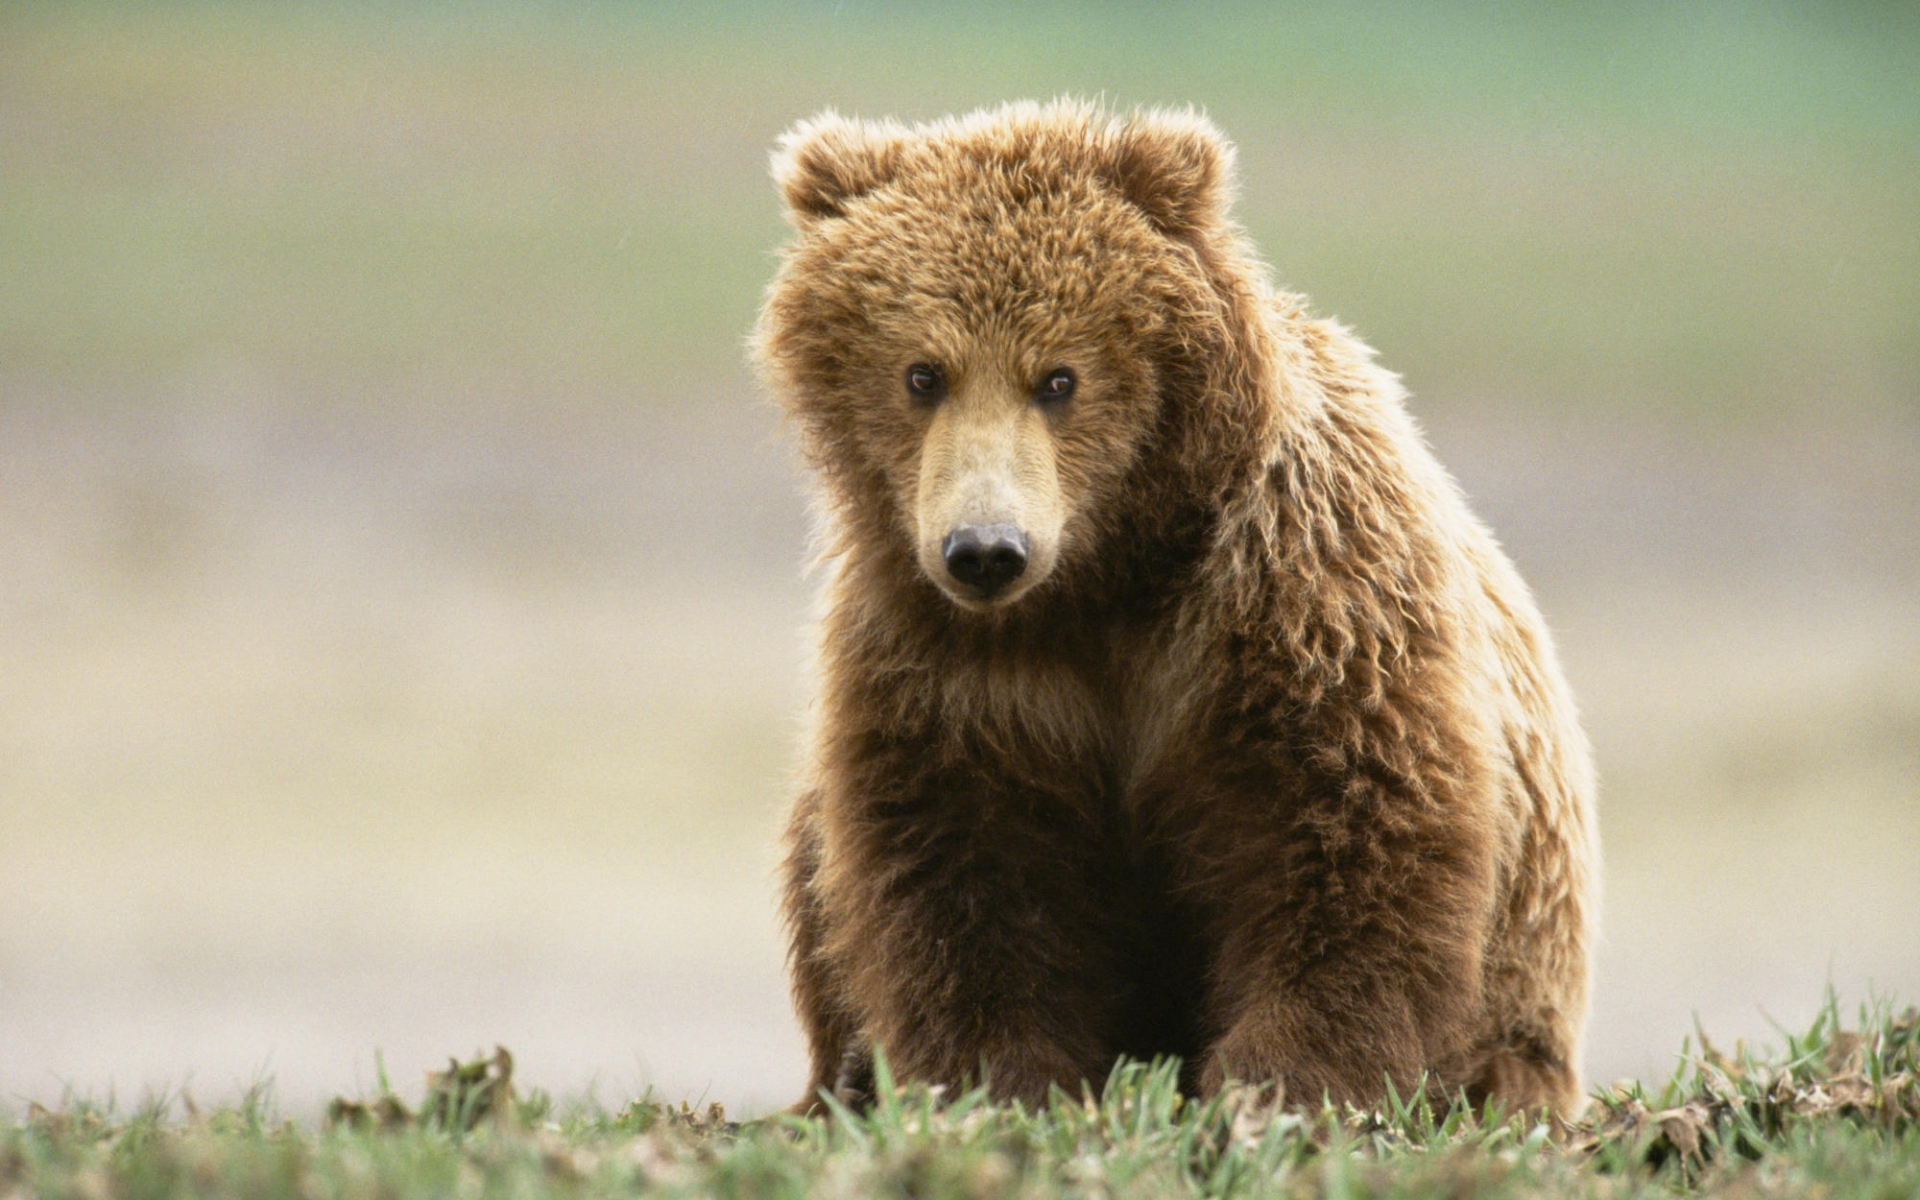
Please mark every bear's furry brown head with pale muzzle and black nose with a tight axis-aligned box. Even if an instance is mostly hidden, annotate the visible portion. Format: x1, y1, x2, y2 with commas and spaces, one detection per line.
755, 102, 1233, 612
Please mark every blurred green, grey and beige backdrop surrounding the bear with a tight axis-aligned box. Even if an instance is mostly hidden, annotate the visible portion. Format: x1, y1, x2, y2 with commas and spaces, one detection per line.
0, 0, 1920, 1116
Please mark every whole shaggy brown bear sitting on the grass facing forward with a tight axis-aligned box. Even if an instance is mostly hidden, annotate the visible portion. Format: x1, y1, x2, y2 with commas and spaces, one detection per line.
755, 102, 1597, 1114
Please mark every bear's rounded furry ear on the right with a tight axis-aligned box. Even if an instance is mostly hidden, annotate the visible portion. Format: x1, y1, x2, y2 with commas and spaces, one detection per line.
1108, 109, 1233, 236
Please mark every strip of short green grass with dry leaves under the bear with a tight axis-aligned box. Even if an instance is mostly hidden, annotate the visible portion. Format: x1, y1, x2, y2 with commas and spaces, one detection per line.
0, 1000, 1920, 1200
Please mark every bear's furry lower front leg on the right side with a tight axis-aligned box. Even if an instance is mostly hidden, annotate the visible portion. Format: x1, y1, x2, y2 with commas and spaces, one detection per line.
1200, 772, 1496, 1104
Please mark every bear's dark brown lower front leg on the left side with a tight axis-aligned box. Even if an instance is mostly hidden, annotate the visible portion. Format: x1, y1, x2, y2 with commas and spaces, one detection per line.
818, 753, 1123, 1102
